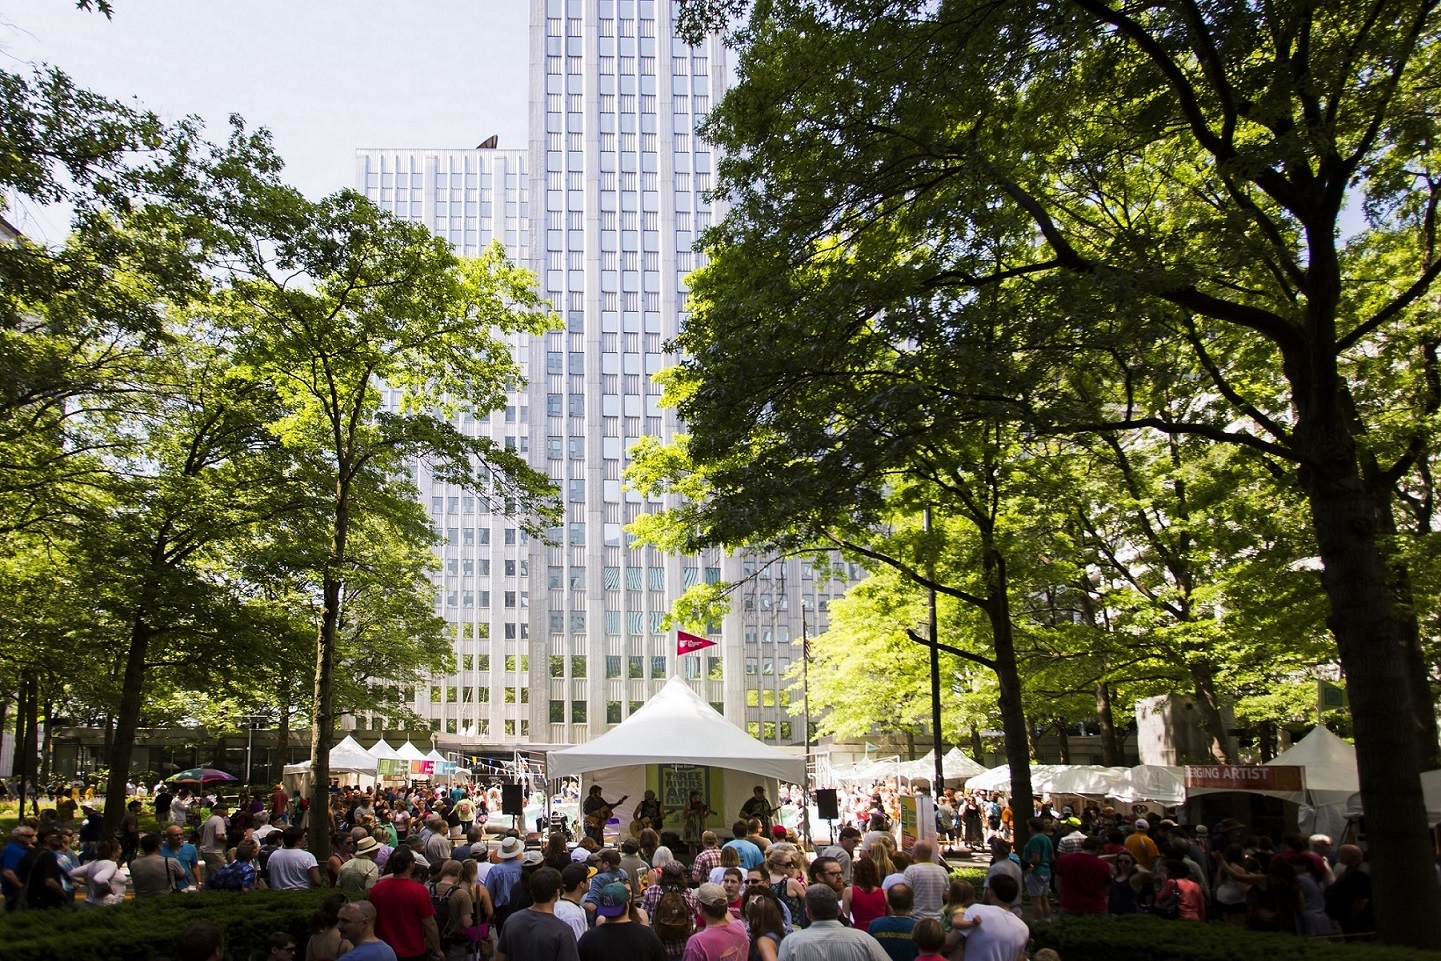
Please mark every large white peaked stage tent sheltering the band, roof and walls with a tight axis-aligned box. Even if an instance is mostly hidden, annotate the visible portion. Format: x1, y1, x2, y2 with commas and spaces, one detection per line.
546, 676, 806, 830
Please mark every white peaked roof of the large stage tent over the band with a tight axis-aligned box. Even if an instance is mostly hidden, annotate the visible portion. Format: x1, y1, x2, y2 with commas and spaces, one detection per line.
546, 676, 806, 784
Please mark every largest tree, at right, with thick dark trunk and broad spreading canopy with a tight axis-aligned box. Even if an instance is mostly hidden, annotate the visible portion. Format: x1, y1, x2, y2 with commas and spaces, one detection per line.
687, 0, 1441, 948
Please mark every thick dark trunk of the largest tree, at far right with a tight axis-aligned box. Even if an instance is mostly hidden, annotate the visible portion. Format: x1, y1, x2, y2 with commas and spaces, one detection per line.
1295, 403, 1441, 949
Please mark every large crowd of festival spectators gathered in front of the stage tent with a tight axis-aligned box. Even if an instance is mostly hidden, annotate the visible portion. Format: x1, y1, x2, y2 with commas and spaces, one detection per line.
0, 784, 1373, 961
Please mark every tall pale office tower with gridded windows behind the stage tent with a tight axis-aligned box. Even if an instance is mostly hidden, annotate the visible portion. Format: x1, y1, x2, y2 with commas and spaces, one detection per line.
356, 0, 856, 751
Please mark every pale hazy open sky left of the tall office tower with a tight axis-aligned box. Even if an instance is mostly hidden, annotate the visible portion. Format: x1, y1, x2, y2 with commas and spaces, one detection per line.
0, 0, 530, 242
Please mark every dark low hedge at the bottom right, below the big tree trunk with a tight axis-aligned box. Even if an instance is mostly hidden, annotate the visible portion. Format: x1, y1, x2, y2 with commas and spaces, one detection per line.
1030, 915, 1437, 961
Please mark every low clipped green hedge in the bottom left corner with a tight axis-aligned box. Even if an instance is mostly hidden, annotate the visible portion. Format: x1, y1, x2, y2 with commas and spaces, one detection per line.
0, 889, 334, 961
